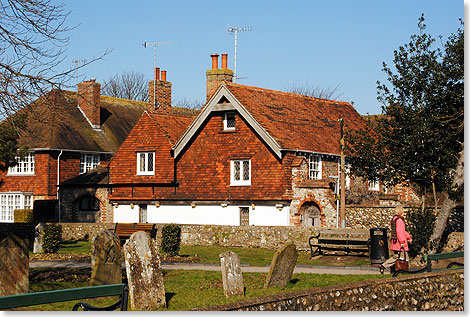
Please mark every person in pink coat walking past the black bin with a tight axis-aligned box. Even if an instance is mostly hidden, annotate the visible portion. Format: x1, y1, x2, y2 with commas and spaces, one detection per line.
379, 205, 412, 274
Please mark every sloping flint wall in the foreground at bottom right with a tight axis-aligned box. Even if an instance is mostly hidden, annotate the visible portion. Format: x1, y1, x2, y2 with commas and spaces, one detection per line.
194, 269, 464, 311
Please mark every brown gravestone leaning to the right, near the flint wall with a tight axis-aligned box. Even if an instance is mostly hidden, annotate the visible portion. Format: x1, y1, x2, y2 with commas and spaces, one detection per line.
264, 242, 298, 288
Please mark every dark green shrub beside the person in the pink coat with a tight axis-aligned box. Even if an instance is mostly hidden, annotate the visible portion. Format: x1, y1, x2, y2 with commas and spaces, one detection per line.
406, 208, 436, 257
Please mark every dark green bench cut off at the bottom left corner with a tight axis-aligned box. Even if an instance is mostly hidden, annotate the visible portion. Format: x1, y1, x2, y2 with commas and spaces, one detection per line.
0, 284, 129, 311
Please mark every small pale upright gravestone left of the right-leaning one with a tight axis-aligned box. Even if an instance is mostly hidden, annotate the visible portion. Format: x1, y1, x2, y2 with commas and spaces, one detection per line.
219, 251, 244, 297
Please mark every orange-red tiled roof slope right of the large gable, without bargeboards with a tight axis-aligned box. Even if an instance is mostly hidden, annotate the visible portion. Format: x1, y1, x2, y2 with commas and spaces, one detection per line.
224, 82, 365, 154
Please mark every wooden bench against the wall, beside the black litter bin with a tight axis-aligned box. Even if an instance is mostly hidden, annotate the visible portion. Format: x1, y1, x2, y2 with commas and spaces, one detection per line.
308, 228, 369, 257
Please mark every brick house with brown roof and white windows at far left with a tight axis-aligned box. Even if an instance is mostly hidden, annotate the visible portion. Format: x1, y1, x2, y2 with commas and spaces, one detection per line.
0, 79, 149, 222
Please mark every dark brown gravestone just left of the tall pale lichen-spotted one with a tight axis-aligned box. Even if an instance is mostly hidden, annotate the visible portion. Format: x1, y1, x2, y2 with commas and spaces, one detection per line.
90, 230, 123, 286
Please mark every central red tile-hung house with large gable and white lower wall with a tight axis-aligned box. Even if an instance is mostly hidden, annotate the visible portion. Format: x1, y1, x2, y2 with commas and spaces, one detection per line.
107, 54, 374, 227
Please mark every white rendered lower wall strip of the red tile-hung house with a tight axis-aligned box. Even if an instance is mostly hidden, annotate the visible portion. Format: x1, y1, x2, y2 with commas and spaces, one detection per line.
114, 205, 289, 226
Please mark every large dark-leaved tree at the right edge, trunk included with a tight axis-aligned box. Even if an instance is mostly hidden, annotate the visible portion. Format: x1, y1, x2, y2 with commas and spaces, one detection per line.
346, 15, 464, 251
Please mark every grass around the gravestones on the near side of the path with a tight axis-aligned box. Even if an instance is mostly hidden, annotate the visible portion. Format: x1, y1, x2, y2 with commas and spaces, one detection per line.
18, 270, 384, 311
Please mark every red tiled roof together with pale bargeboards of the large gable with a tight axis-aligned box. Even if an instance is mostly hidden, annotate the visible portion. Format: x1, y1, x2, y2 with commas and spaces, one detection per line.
174, 82, 364, 157
